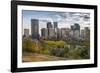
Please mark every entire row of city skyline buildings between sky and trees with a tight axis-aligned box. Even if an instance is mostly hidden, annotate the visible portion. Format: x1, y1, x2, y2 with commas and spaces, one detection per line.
23, 19, 90, 40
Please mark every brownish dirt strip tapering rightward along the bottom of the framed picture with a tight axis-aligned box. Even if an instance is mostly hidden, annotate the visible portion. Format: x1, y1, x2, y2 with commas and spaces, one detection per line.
22, 52, 66, 62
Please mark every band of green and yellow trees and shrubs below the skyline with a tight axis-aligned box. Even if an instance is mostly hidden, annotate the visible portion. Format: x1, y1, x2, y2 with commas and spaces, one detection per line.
22, 38, 90, 60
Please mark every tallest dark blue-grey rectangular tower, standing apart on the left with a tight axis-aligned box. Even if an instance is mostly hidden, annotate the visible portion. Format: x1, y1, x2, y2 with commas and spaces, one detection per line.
31, 19, 39, 39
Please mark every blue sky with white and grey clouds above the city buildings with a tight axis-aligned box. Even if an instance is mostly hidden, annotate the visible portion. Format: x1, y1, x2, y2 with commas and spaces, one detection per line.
22, 10, 90, 35
